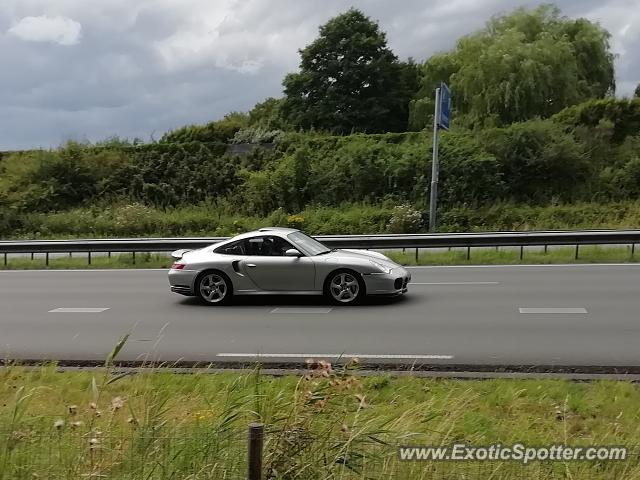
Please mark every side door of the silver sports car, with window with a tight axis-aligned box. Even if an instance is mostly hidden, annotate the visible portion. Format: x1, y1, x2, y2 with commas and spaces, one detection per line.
240, 235, 316, 292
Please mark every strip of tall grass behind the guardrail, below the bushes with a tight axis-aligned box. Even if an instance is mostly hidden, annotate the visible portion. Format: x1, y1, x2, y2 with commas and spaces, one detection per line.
6, 202, 640, 239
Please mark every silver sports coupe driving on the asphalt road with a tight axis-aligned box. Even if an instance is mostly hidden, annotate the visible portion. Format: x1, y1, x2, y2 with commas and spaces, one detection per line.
169, 228, 411, 305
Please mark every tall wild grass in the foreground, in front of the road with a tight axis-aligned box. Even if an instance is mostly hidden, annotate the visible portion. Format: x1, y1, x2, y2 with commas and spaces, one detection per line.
0, 364, 640, 480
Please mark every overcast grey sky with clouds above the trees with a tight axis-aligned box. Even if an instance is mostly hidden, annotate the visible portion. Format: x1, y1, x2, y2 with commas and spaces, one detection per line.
0, 0, 640, 150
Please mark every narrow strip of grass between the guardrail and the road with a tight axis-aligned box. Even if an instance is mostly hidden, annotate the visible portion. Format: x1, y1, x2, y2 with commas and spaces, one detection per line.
0, 246, 640, 270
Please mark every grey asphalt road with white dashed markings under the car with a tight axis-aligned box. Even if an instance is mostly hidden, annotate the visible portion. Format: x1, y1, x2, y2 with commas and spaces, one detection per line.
0, 264, 640, 366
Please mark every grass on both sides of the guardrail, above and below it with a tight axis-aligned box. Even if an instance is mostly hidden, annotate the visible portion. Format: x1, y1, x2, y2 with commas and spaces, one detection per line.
0, 202, 640, 269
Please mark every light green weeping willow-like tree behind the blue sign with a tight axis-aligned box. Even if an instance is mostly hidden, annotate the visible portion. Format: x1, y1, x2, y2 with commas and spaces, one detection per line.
412, 5, 615, 125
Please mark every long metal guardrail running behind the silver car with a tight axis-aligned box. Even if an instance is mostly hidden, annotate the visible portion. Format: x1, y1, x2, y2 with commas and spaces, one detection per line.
0, 230, 640, 254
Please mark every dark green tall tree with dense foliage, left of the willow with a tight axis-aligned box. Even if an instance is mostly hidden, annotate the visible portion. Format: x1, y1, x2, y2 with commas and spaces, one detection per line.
281, 9, 418, 133
